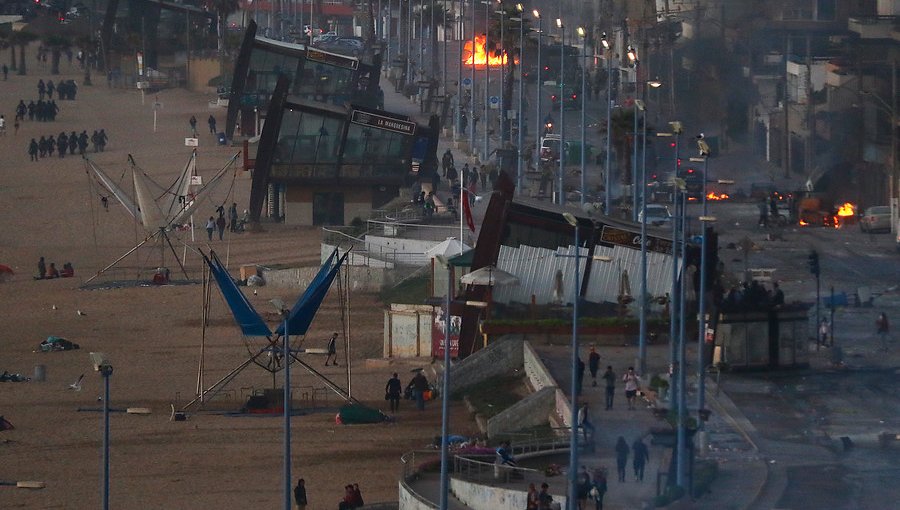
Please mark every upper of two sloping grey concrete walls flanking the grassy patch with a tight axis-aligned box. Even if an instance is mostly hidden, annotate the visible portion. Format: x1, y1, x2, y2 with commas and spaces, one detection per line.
450, 335, 523, 395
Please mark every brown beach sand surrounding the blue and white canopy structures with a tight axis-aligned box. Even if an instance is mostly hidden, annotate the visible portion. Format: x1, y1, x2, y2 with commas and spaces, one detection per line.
0, 53, 475, 509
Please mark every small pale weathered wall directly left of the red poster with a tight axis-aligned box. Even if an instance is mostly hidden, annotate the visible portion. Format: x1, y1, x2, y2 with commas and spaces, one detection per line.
382, 304, 432, 358
